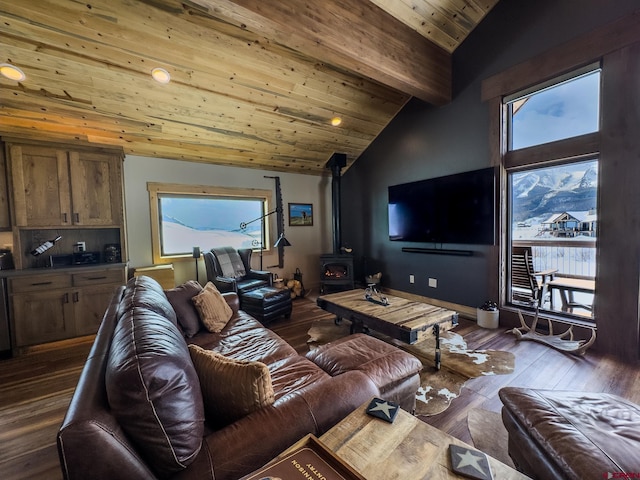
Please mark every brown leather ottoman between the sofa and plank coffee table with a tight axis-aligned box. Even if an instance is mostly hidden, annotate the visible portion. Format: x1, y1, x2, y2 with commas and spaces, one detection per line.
307, 333, 422, 413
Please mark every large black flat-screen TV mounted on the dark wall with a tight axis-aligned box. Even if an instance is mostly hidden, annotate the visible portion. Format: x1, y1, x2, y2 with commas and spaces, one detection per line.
389, 168, 496, 245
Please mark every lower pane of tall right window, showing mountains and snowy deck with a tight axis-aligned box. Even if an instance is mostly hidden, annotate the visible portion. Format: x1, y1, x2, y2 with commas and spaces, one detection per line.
509, 159, 598, 318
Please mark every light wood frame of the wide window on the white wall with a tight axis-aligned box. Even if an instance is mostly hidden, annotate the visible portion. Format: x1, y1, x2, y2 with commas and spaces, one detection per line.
147, 182, 273, 264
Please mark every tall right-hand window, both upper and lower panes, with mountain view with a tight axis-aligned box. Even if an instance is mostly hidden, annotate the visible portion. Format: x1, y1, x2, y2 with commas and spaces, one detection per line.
505, 67, 600, 320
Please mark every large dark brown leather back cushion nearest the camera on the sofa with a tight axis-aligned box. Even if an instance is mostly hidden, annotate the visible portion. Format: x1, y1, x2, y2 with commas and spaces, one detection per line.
105, 306, 204, 477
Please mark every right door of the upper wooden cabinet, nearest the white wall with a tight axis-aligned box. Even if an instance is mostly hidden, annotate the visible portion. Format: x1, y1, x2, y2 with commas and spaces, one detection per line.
69, 152, 122, 225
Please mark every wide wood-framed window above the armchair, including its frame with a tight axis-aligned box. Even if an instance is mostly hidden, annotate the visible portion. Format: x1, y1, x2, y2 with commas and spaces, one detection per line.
147, 183, 271, 263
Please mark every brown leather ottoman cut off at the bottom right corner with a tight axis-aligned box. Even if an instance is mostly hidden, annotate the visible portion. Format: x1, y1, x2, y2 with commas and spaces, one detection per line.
499, 387, 640, 480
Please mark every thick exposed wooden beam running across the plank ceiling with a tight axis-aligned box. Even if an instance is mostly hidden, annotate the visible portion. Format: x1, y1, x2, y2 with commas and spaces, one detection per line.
188, 0, 451, 105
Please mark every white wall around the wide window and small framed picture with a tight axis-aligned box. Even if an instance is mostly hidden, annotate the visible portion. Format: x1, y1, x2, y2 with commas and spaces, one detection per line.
124, 155, 332, 292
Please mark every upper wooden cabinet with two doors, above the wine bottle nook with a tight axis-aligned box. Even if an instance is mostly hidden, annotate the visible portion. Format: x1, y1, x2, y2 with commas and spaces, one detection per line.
8, 144, 123, 227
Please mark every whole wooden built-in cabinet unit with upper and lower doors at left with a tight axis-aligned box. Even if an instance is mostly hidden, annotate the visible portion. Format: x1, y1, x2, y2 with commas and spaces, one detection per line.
0, 137, 127, 354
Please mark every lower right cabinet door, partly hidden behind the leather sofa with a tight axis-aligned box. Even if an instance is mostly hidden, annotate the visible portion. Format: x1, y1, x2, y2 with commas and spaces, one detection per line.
72, 283, 121, 335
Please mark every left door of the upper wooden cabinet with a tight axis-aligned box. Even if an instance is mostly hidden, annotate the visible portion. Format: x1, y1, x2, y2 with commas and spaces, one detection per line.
9, 145, 71, 227
